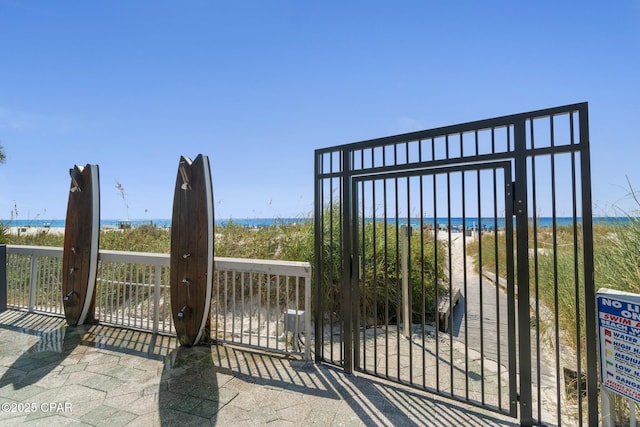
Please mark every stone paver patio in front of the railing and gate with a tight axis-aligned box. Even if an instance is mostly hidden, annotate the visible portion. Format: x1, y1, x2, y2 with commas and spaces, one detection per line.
0, 310, 518, 426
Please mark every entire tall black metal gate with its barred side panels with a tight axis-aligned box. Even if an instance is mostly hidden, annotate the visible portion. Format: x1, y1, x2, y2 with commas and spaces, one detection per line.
315, 103, 597, 425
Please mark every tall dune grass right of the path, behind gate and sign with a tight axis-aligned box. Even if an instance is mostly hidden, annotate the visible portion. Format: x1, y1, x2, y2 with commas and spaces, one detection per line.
467, 216, 640, 358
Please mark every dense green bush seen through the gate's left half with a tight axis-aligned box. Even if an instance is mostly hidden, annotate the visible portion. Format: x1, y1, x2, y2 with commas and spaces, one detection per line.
309, 205, 446, 326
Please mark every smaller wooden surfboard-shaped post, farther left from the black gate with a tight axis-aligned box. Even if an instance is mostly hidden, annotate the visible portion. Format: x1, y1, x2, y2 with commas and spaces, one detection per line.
62, 164, 100, 326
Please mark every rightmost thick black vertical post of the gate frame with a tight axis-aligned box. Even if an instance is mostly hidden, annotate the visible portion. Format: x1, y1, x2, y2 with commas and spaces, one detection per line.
579, 104, 598, 425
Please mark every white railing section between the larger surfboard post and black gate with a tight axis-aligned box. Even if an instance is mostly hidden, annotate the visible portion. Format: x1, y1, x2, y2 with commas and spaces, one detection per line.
211, 258, 311, 359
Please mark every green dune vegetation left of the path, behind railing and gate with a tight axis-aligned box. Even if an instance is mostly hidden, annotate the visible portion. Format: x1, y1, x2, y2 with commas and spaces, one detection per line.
9, 214, 445, 323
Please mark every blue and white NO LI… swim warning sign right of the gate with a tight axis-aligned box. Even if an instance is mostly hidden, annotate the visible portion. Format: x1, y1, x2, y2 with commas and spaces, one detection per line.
596, 289, 640, 403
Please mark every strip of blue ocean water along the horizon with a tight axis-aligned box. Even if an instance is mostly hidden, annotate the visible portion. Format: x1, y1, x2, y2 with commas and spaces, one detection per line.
0, 217, 632, 230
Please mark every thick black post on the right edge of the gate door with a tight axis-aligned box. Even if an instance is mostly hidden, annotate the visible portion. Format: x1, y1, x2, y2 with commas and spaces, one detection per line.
514, 119, 533, 426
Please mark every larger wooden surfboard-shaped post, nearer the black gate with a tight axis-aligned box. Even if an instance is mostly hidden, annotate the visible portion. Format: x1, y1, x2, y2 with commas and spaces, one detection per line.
170, 154, 213, 346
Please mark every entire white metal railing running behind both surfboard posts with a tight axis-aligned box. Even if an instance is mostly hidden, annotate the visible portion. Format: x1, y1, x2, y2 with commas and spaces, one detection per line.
6, 245, 311, 359
